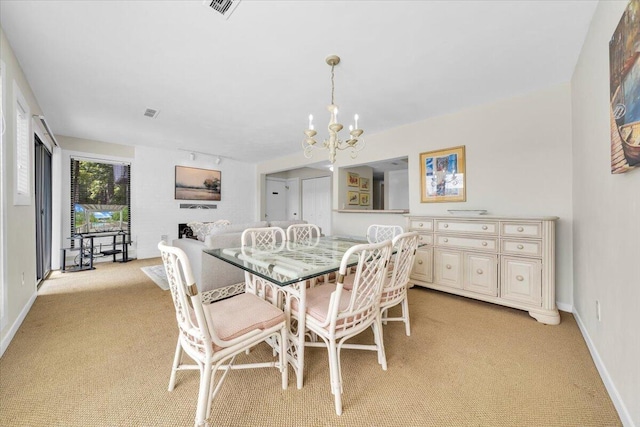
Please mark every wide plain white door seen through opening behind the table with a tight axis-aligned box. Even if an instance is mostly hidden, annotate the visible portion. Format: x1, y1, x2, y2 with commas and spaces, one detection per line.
302, 176, 331, 236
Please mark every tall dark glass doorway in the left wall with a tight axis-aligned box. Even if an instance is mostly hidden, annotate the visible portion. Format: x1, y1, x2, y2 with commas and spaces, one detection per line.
34, 135, 52, 287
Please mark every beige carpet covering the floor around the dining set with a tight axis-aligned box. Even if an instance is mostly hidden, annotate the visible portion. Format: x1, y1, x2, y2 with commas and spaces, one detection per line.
0, 258, 621, 427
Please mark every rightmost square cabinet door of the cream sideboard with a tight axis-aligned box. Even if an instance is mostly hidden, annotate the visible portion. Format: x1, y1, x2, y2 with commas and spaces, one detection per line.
500, 256, 542, 307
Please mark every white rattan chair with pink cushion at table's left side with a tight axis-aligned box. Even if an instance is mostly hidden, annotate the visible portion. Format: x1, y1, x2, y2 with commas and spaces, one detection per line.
158, 242, 288, 426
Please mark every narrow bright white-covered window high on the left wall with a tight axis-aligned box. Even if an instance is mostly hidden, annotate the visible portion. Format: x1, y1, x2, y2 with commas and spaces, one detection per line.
13, 82, 31, 205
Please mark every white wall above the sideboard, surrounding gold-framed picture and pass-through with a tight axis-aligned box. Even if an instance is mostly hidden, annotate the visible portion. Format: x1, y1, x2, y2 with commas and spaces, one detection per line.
258, 84, 573, 310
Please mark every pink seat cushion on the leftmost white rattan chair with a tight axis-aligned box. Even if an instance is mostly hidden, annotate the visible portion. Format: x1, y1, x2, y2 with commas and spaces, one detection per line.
203, 293, 285, 341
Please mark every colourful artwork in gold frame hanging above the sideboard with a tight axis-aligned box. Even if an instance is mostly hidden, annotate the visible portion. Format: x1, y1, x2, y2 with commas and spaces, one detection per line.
420, 145, 467, 203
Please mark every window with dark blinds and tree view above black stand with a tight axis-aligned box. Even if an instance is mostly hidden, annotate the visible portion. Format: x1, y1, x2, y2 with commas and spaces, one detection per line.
71, 158, 131, 234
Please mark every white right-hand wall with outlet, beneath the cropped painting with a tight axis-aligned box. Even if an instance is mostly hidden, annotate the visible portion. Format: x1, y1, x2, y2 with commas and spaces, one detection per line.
572, 1, 640, 426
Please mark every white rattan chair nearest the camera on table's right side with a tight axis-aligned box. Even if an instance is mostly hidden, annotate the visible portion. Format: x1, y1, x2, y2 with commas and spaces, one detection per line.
292, 240, 391, 415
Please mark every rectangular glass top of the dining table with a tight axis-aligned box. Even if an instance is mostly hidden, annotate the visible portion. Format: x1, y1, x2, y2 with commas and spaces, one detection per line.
204, 236, 367, 286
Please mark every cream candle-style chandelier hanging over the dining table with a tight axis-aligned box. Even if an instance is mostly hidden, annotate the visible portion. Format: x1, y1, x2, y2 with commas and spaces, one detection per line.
302, 55, 365, 164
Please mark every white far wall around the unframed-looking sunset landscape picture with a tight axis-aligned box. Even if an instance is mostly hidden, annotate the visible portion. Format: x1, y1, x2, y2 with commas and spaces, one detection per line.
131, 147, 257, 258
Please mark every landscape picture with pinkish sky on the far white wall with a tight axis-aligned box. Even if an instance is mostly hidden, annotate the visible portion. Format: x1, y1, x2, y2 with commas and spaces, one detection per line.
175, 166, 222, 200
